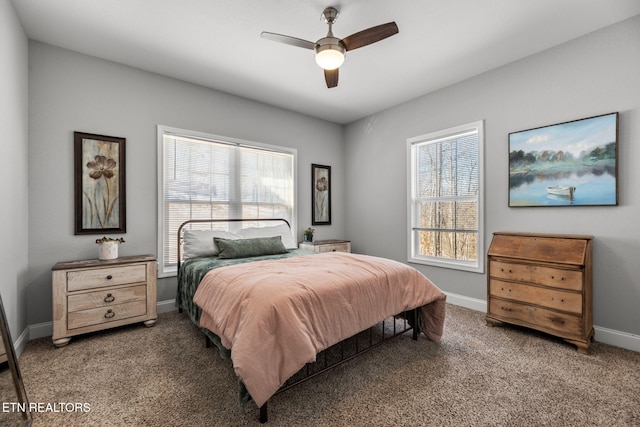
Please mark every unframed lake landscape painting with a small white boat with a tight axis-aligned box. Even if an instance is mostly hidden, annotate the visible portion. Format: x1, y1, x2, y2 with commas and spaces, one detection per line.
509, 112, 618, 207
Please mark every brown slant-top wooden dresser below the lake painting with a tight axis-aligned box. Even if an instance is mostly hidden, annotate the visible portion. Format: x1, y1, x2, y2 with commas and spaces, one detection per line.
487, 232, 594, 354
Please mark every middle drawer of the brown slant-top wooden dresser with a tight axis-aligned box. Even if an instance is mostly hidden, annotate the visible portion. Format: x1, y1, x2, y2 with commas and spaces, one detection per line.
489, 278, 582, 314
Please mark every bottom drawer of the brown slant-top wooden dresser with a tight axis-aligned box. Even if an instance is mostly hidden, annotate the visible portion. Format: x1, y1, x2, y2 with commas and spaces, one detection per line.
489, 298, 584, 336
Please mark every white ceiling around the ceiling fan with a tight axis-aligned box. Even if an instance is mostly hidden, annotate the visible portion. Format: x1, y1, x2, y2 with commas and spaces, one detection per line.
12, 0, 640, 124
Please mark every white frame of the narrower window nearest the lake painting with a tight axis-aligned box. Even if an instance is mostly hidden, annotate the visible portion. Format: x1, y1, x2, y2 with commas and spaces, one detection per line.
407, 120, 485, 273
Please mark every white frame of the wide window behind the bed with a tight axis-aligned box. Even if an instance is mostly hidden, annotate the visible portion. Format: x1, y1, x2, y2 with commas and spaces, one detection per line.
157, 125, 298, 278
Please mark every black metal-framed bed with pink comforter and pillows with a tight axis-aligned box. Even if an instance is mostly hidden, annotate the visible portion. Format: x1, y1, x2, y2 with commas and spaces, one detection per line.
176, 219, 446, 422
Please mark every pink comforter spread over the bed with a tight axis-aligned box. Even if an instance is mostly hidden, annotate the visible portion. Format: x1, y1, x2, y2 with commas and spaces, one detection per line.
193, 252, 446, 406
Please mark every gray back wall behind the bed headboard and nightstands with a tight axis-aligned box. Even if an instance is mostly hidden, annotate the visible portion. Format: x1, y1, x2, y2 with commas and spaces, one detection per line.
23, 41, 346, 325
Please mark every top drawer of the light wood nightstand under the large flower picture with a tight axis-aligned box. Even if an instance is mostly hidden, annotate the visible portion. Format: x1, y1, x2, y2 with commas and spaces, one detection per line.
67, 264, 147, 292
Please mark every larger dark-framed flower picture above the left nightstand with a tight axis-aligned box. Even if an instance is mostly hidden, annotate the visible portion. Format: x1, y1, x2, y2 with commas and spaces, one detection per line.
73, 132, 127, 234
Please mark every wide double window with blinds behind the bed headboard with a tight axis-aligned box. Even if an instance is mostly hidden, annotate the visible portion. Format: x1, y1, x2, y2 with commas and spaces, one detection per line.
158, 126, 296, 277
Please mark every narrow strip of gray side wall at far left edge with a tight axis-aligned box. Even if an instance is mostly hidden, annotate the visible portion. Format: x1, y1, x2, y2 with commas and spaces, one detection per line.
0, 0, 29, 341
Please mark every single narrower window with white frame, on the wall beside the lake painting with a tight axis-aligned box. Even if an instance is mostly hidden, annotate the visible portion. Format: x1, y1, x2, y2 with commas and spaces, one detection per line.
407, 121, 484, 273
